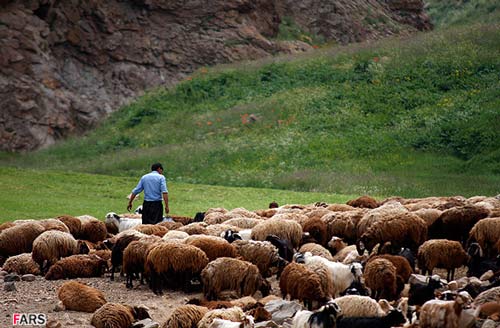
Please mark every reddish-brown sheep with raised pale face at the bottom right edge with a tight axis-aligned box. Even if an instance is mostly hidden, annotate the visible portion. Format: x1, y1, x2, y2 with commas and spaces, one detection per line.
419, 292, 467, 328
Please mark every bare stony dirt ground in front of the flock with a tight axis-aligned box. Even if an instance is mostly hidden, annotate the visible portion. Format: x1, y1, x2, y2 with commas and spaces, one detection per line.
0, 267, 466, 328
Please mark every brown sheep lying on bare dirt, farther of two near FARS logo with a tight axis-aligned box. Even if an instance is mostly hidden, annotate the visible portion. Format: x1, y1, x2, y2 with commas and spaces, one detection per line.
57, 281, 107, 313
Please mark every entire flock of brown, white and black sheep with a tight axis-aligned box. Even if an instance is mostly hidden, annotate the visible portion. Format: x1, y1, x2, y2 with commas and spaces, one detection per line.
0, 196, 500, 328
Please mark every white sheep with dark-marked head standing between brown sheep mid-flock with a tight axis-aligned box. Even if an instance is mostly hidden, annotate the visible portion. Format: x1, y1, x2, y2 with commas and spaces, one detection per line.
304, 252, 363, 297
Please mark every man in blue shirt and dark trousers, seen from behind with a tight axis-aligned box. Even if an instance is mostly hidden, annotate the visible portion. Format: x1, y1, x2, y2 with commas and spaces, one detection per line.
127, 163, 170, 224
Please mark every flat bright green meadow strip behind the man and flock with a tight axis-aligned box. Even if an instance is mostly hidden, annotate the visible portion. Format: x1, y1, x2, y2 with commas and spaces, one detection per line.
0, 168, 354, 223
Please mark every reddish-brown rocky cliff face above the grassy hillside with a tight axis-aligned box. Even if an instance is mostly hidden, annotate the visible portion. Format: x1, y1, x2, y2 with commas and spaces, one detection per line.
0, 0, 430, 151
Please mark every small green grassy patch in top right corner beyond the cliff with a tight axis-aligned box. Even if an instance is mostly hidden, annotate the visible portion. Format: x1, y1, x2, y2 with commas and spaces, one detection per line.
425, 0, 500, 28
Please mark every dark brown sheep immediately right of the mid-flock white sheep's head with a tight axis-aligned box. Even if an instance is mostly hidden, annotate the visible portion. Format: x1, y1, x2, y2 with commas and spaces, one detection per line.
363, 258, 398, 301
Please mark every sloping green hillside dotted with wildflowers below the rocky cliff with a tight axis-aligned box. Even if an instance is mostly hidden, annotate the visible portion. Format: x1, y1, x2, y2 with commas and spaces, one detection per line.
0, 25, 500, 202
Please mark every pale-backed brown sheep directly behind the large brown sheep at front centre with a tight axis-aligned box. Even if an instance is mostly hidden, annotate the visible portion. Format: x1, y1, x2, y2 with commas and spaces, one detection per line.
232, 240, 279, 278
